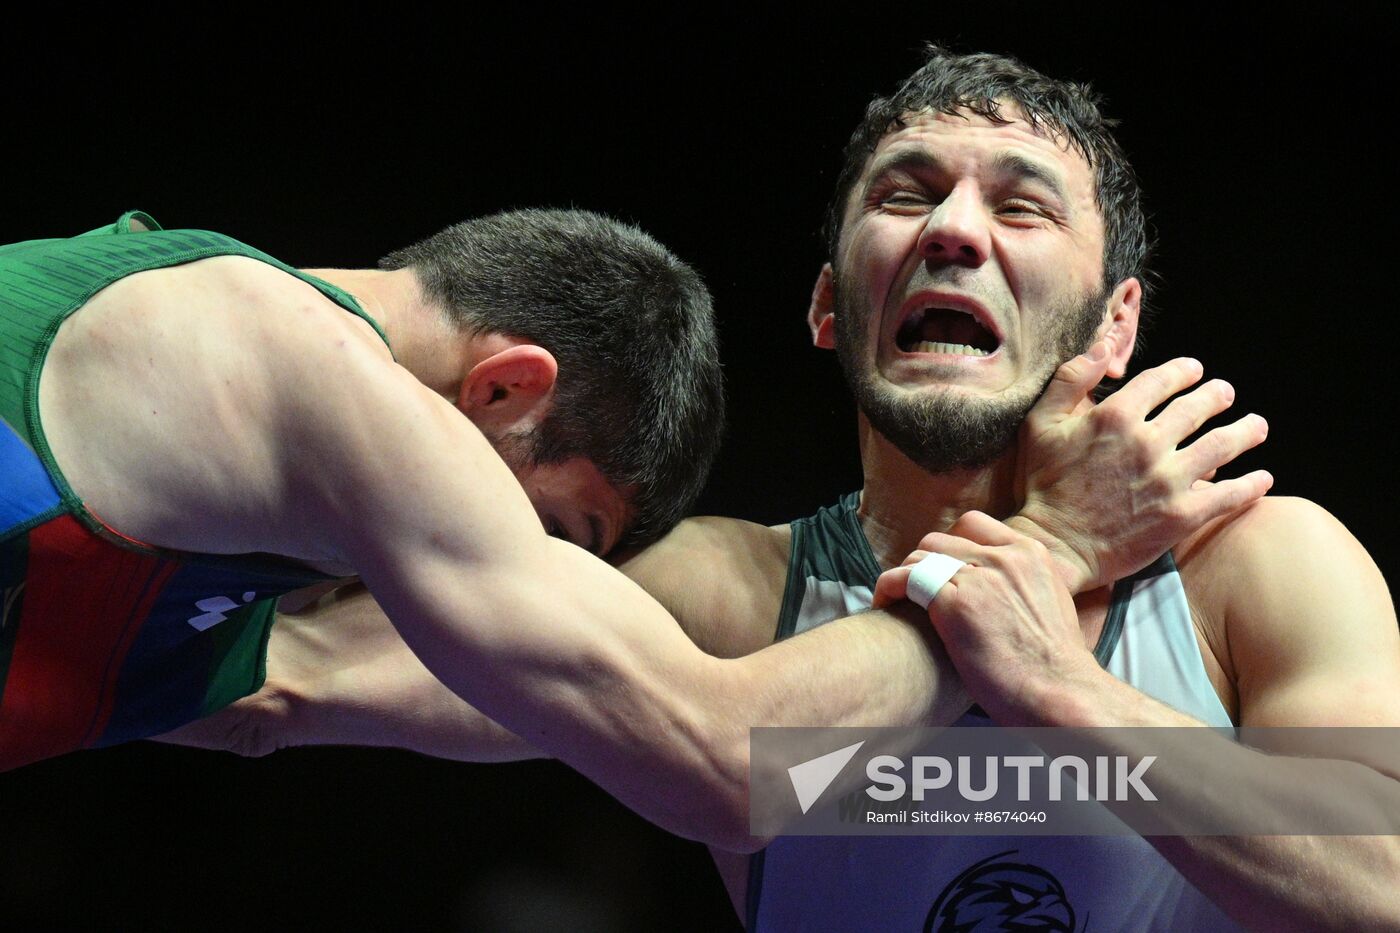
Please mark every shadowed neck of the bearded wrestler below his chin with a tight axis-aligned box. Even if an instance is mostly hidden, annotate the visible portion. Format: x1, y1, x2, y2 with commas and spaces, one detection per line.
860, 415, 1016, 567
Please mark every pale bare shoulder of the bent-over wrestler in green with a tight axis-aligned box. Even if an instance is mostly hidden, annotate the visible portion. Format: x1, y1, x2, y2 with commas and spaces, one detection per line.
39, 250, 430, 560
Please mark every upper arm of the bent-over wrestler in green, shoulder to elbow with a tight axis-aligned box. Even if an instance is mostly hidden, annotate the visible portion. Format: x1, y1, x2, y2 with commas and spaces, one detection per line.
281, 353, 753, 838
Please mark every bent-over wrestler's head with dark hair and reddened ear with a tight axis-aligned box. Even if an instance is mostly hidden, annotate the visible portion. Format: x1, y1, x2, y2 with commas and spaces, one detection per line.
379, 210, 724, 553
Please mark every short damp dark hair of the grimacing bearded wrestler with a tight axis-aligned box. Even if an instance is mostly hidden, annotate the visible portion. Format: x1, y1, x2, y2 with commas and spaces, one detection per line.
826, 43, 1152, 323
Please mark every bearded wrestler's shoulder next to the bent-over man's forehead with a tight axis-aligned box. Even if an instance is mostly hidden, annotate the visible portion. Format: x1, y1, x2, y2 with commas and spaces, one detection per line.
619, 516, 791, 657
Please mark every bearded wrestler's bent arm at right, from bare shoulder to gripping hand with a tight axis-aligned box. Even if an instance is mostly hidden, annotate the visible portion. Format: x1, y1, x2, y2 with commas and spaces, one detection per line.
882, 499, 1400, 929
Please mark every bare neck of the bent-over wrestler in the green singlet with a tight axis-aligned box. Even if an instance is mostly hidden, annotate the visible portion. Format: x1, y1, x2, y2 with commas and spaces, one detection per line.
302, 269, 469, 399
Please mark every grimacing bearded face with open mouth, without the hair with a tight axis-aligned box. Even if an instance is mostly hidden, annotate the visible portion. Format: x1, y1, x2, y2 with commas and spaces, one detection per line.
833, 105, 1135, 472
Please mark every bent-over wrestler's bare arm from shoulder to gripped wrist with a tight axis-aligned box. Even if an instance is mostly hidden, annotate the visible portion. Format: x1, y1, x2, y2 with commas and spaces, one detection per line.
93, 261, 957, 845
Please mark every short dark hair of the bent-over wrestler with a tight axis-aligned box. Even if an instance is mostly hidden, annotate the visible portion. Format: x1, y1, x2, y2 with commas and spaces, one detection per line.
379, 210, 724, 544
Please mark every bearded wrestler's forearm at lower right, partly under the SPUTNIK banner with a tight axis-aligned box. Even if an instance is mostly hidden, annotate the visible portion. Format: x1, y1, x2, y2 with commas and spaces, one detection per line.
1037, 678, 1400, 929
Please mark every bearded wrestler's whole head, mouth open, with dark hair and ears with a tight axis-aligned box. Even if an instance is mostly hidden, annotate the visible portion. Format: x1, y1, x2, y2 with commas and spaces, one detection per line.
809, 46, 1149, 472
